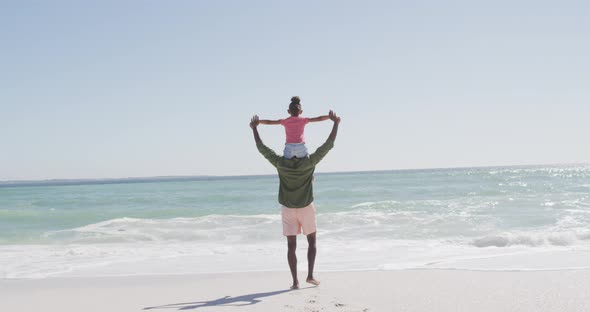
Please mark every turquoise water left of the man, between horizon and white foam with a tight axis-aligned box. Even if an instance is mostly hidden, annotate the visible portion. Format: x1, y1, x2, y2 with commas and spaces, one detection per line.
0, 177, 275, 244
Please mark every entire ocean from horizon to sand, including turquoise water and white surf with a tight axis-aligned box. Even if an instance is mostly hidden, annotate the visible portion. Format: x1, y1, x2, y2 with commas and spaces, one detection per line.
0, 165, 590, 278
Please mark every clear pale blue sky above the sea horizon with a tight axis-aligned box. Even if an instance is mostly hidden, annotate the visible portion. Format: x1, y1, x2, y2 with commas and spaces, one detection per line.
0, 0, 590, 181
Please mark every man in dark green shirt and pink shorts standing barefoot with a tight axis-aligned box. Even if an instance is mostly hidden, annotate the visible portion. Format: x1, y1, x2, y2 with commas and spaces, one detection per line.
250, 111, 340, 289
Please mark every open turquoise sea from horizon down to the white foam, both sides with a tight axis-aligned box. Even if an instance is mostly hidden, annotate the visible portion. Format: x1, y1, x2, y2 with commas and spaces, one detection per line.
0, 165, 590, 244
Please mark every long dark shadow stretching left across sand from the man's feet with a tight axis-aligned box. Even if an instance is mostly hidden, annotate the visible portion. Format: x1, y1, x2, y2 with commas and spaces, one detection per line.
143, 288, 306, 310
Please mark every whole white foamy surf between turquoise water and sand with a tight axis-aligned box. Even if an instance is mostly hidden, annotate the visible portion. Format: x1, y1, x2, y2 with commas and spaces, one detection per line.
0, 212, 590, 278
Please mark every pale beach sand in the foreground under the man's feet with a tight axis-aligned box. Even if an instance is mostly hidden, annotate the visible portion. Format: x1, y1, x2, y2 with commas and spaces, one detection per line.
0, 269, 590, 312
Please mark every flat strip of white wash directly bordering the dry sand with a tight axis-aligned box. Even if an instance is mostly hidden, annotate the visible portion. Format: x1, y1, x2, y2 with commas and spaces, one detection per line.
0, 236, 590, 278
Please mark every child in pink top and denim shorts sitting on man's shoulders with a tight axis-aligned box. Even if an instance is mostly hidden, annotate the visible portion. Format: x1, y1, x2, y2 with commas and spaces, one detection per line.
260, 96, 330, 159
